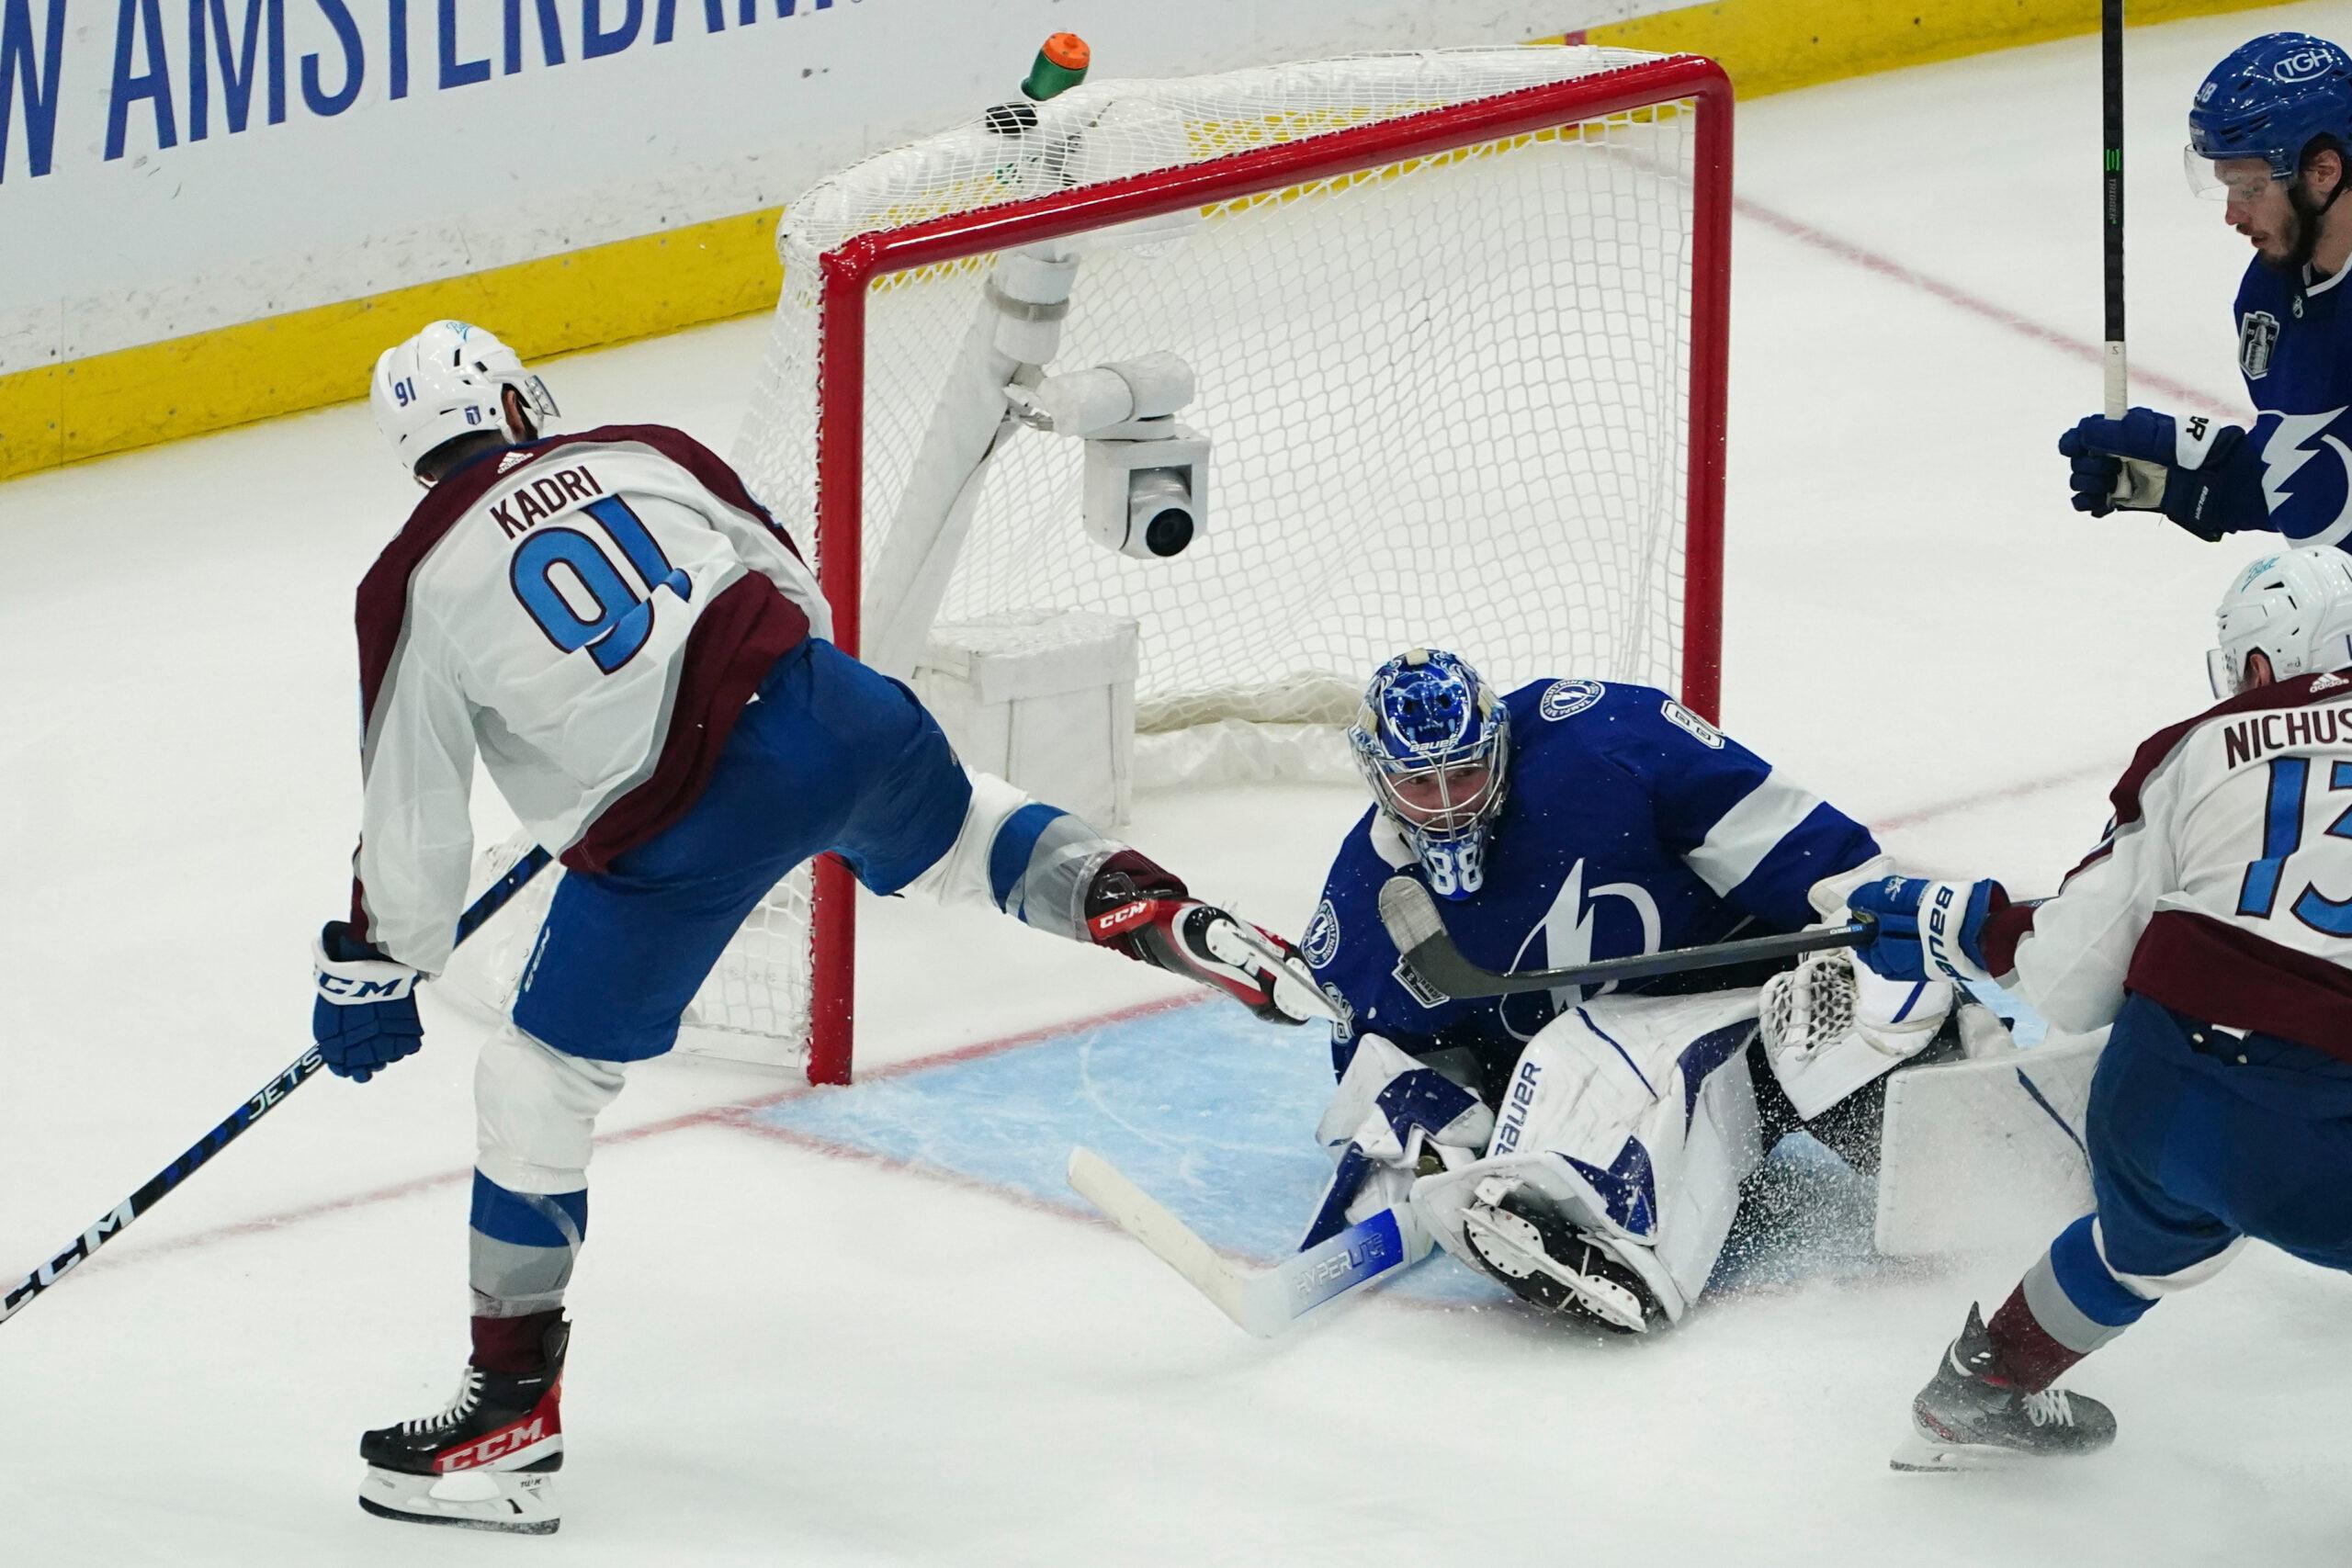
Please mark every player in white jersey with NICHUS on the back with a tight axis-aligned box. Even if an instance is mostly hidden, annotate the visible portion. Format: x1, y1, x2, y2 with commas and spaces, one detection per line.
1851, 546, 2352, 1470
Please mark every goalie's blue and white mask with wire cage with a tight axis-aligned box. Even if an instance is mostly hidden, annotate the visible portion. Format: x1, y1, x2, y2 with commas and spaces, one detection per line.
1348, 649, 1510, 898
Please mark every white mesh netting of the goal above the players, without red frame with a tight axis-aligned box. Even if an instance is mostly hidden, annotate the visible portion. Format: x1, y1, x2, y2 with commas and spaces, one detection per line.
739, 50, 1693, 731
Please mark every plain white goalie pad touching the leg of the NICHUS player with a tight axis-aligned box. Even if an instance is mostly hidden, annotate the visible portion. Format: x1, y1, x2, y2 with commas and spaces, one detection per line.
1877, 1032, 2108, 1258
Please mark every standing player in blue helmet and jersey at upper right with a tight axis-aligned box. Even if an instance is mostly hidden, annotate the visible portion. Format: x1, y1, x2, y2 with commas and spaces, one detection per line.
2058, 33, 2352, 546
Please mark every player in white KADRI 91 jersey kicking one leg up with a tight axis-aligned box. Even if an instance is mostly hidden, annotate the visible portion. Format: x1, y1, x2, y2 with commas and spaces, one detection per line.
312, 322, 1327, 1533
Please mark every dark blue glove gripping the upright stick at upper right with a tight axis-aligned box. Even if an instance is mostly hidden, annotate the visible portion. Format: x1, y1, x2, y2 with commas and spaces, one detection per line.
2058, 409, 2269, 543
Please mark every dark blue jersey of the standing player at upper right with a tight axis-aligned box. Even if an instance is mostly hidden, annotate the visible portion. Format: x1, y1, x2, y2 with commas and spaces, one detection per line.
2237, 261, 2352, 546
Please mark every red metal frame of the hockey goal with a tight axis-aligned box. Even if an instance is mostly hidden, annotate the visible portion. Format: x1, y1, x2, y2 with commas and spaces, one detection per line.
748, 56, 1731, 1084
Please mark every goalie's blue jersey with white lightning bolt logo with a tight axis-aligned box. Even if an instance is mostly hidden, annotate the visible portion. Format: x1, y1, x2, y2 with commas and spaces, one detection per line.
1303, 680, 1879, 1075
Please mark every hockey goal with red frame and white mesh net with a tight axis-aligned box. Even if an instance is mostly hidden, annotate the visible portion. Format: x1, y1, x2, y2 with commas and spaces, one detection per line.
448, 47, 1731, 1081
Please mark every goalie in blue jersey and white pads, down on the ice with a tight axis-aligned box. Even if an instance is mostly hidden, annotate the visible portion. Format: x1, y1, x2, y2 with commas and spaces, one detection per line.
1303, 649, 1952, 1331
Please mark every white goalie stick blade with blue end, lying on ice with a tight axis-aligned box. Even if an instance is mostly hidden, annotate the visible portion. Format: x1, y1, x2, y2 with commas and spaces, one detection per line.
1070, 1149, 1430, 1340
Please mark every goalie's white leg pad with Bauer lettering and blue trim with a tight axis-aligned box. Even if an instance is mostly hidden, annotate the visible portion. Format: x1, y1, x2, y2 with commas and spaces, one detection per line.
1411, 989, 1764, 1319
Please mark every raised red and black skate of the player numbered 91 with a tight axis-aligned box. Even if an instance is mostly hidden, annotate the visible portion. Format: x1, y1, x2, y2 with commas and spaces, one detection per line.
1087, 849, 1331, 1022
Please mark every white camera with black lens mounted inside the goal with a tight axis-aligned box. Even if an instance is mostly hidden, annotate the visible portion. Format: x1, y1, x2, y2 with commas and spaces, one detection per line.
1007, 353, 1209, 559
